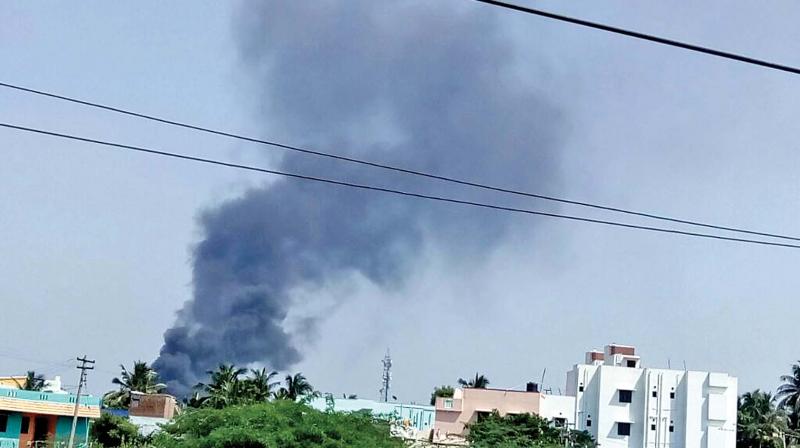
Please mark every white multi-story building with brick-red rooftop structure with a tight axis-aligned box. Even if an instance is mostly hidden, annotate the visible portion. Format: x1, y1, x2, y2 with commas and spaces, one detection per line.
564, 344, 737, 448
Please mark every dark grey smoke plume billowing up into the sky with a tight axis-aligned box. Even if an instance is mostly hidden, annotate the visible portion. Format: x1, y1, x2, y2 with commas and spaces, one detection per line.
155, 0, 561, 394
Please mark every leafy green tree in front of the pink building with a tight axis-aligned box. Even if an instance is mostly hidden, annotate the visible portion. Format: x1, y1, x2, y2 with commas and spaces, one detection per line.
467, 411, 594, 448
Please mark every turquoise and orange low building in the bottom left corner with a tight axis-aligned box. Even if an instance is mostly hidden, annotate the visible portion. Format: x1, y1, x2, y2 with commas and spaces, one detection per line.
0, 377, 100, 448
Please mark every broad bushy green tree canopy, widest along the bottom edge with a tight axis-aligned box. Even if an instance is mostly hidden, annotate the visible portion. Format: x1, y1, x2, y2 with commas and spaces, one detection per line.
154, 400, 404, 448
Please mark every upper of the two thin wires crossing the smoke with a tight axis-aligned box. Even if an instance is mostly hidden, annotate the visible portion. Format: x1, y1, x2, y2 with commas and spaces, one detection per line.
0, 82, 800, 241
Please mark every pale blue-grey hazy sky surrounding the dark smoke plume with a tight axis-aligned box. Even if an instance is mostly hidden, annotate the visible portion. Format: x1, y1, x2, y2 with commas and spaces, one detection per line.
0, 0, 800, 401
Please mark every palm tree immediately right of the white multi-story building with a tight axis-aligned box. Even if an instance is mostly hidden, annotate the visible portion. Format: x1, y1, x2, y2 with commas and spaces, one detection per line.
736, 389, 789, 448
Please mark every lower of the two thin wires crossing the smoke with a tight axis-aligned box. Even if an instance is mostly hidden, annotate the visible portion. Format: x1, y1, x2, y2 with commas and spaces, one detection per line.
0, 122, 800, 249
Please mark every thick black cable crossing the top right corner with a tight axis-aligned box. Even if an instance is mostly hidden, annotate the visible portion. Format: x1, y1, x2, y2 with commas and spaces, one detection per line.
474, 0, 800, 75
